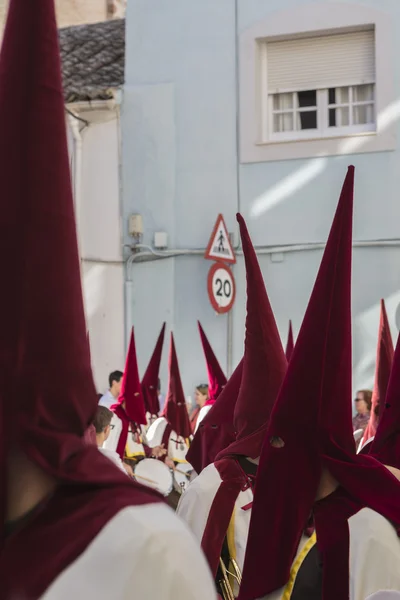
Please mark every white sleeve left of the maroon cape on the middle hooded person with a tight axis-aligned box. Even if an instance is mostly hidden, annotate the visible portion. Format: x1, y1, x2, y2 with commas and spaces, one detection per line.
176, 464, 222, 544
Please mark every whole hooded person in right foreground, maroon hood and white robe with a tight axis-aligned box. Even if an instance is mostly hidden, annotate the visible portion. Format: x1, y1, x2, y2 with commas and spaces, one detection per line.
239, 167, 400, 600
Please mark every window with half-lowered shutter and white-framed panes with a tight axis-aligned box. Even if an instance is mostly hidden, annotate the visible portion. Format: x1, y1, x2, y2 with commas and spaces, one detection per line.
261, 29, 376, 142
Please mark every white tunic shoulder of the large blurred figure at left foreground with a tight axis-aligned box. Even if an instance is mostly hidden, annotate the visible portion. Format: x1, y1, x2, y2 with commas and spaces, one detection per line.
42, 504, 216, 600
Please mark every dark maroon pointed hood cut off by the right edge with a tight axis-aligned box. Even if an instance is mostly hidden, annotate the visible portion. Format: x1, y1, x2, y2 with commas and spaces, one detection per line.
370, 336, 400, 469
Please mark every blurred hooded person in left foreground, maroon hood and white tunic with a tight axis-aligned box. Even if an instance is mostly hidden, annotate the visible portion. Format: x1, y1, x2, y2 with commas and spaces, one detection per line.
0, 0, 213, 600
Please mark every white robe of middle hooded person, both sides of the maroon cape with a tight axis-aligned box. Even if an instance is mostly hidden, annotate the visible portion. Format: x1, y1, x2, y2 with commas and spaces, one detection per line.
177, 464, 253, 593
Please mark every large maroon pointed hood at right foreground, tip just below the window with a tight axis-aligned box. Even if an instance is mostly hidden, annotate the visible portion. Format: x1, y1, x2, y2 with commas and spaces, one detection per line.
239, 167, 400, 600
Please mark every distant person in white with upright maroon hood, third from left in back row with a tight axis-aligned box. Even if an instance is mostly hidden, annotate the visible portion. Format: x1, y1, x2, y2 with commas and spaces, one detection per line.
146, 333, 191, 463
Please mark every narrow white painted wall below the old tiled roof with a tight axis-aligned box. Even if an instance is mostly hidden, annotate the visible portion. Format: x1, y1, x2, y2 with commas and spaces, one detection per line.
68, 105, 124, 392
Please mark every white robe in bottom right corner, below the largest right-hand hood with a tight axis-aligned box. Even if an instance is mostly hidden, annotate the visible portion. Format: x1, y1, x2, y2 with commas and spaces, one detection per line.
262, 508, 400, 600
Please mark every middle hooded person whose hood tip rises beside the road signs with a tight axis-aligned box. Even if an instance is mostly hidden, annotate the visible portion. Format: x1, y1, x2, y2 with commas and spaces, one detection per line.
178, 215, 287, 596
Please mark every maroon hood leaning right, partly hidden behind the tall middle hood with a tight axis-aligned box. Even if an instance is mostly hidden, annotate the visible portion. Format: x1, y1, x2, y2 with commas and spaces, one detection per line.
186, 360, 243, 475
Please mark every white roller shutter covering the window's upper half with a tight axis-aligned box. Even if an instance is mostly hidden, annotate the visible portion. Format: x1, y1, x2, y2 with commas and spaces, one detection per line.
266, 29, 375, 94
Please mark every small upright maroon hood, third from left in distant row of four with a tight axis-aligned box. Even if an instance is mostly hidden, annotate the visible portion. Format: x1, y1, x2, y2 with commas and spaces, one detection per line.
163, 333, 192, 438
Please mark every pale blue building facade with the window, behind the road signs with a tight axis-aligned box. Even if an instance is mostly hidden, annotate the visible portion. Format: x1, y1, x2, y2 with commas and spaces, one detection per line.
123, 0, 400, 394
